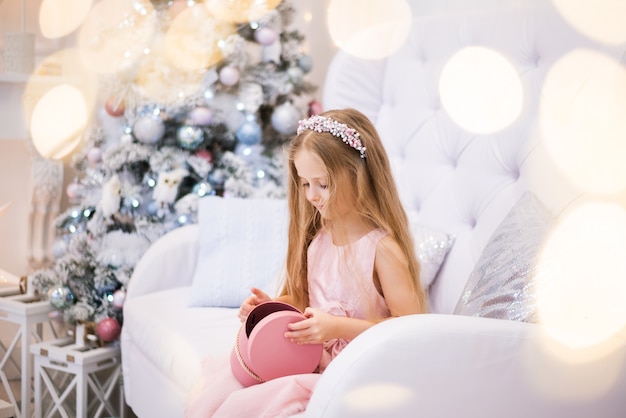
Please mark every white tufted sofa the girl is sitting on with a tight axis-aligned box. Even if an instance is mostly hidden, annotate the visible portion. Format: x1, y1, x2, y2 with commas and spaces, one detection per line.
121, 5, 626, 418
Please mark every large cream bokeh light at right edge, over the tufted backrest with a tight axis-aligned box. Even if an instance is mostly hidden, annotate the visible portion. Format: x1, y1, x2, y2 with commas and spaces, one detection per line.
539, 49, 626, 194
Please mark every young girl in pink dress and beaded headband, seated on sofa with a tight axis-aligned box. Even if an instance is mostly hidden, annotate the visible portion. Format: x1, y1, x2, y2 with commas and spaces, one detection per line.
187, 109, 426, 417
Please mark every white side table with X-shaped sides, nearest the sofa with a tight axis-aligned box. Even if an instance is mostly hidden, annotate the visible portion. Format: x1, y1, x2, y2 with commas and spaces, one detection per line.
31, 338, 125, 418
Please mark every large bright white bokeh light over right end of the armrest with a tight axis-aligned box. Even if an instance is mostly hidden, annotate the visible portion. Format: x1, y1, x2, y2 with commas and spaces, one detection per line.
537, 201, 626, 354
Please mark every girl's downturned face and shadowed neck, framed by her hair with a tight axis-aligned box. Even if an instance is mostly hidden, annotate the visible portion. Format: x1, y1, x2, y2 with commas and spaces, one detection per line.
293, 149, 356, 219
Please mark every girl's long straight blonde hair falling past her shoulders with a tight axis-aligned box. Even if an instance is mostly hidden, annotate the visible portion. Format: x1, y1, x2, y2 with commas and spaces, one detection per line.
282, 109, 426, 309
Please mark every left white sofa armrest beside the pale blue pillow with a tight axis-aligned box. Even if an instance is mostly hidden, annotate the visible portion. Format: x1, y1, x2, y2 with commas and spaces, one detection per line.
126, 224, 200, 298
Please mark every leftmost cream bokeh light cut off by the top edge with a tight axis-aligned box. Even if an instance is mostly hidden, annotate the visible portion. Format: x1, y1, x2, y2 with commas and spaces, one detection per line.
39, 0, 93, 39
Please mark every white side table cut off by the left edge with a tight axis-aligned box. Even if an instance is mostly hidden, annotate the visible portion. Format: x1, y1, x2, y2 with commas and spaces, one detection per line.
0, 294, 54, 418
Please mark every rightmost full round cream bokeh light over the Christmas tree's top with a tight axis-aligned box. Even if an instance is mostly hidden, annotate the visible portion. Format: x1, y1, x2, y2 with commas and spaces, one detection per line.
165, 5, 235, 70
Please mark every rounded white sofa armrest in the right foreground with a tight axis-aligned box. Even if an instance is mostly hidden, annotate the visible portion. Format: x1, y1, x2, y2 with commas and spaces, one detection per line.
307, 314, 626, 418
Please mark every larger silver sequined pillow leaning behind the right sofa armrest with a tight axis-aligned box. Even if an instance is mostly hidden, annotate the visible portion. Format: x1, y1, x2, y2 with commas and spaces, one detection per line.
454, 192, 554, 322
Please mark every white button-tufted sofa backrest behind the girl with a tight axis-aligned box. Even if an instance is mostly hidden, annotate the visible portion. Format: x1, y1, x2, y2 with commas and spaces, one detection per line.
324, 2, 621, 313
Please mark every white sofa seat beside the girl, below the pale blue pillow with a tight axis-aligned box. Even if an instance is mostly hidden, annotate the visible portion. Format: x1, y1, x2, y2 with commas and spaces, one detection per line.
124, 286, 240, 391
